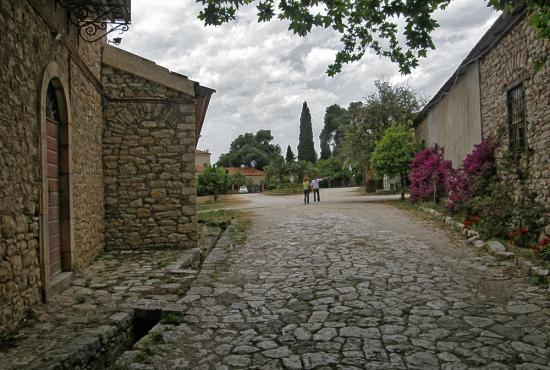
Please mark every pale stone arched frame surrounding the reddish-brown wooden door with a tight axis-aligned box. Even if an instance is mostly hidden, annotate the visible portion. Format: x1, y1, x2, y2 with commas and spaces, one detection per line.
38, 62, 74, 301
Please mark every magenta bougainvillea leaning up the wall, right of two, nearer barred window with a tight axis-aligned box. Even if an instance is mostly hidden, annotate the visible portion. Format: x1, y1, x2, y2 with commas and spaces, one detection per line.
445, 138, 495, 210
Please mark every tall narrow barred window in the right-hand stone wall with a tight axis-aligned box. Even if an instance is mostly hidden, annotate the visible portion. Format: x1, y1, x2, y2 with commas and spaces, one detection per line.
507, 83, 527, 151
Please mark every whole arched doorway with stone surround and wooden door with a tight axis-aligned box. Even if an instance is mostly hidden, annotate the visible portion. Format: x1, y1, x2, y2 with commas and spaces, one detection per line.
40, 63, 73, 300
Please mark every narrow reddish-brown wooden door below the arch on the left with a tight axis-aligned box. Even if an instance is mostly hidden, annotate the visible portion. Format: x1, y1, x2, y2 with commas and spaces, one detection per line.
46, 118, 63, 278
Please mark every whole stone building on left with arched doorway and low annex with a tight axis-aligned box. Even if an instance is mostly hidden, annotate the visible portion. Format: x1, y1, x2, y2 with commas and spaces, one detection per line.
0, 0, 213, 333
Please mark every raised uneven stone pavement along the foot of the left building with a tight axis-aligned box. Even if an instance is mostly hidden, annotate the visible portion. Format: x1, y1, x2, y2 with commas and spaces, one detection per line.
0, 224, 224, 369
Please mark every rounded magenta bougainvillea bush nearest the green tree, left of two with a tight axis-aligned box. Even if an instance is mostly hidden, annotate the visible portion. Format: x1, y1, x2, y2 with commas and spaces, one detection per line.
409, 144, 453, 201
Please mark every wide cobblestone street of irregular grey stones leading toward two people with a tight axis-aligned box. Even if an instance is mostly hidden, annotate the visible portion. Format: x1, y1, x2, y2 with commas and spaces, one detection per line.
120, 189, 550, 369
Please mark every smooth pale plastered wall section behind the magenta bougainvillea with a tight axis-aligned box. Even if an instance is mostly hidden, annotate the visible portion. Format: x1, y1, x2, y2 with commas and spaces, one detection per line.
415, 63, 481, 168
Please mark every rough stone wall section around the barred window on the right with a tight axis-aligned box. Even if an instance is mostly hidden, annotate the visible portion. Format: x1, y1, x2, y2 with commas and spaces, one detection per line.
480, 19, 550, 206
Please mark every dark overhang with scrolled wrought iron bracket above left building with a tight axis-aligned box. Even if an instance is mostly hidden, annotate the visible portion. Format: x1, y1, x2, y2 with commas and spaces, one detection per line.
58, 0, 131, 42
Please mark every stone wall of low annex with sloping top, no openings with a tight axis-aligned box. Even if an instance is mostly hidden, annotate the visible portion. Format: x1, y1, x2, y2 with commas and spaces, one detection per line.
102, 66, 197, 249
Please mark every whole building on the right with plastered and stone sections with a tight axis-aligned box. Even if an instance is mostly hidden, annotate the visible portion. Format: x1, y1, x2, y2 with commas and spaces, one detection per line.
414, 10, 550, 207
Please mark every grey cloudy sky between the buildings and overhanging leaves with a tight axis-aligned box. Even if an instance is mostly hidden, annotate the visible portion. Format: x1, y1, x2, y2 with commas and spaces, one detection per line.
120, 0, 497, 161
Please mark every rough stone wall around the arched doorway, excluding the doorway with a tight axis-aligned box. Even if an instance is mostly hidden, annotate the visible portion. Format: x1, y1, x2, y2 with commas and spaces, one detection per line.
0, 0, 103, 332
